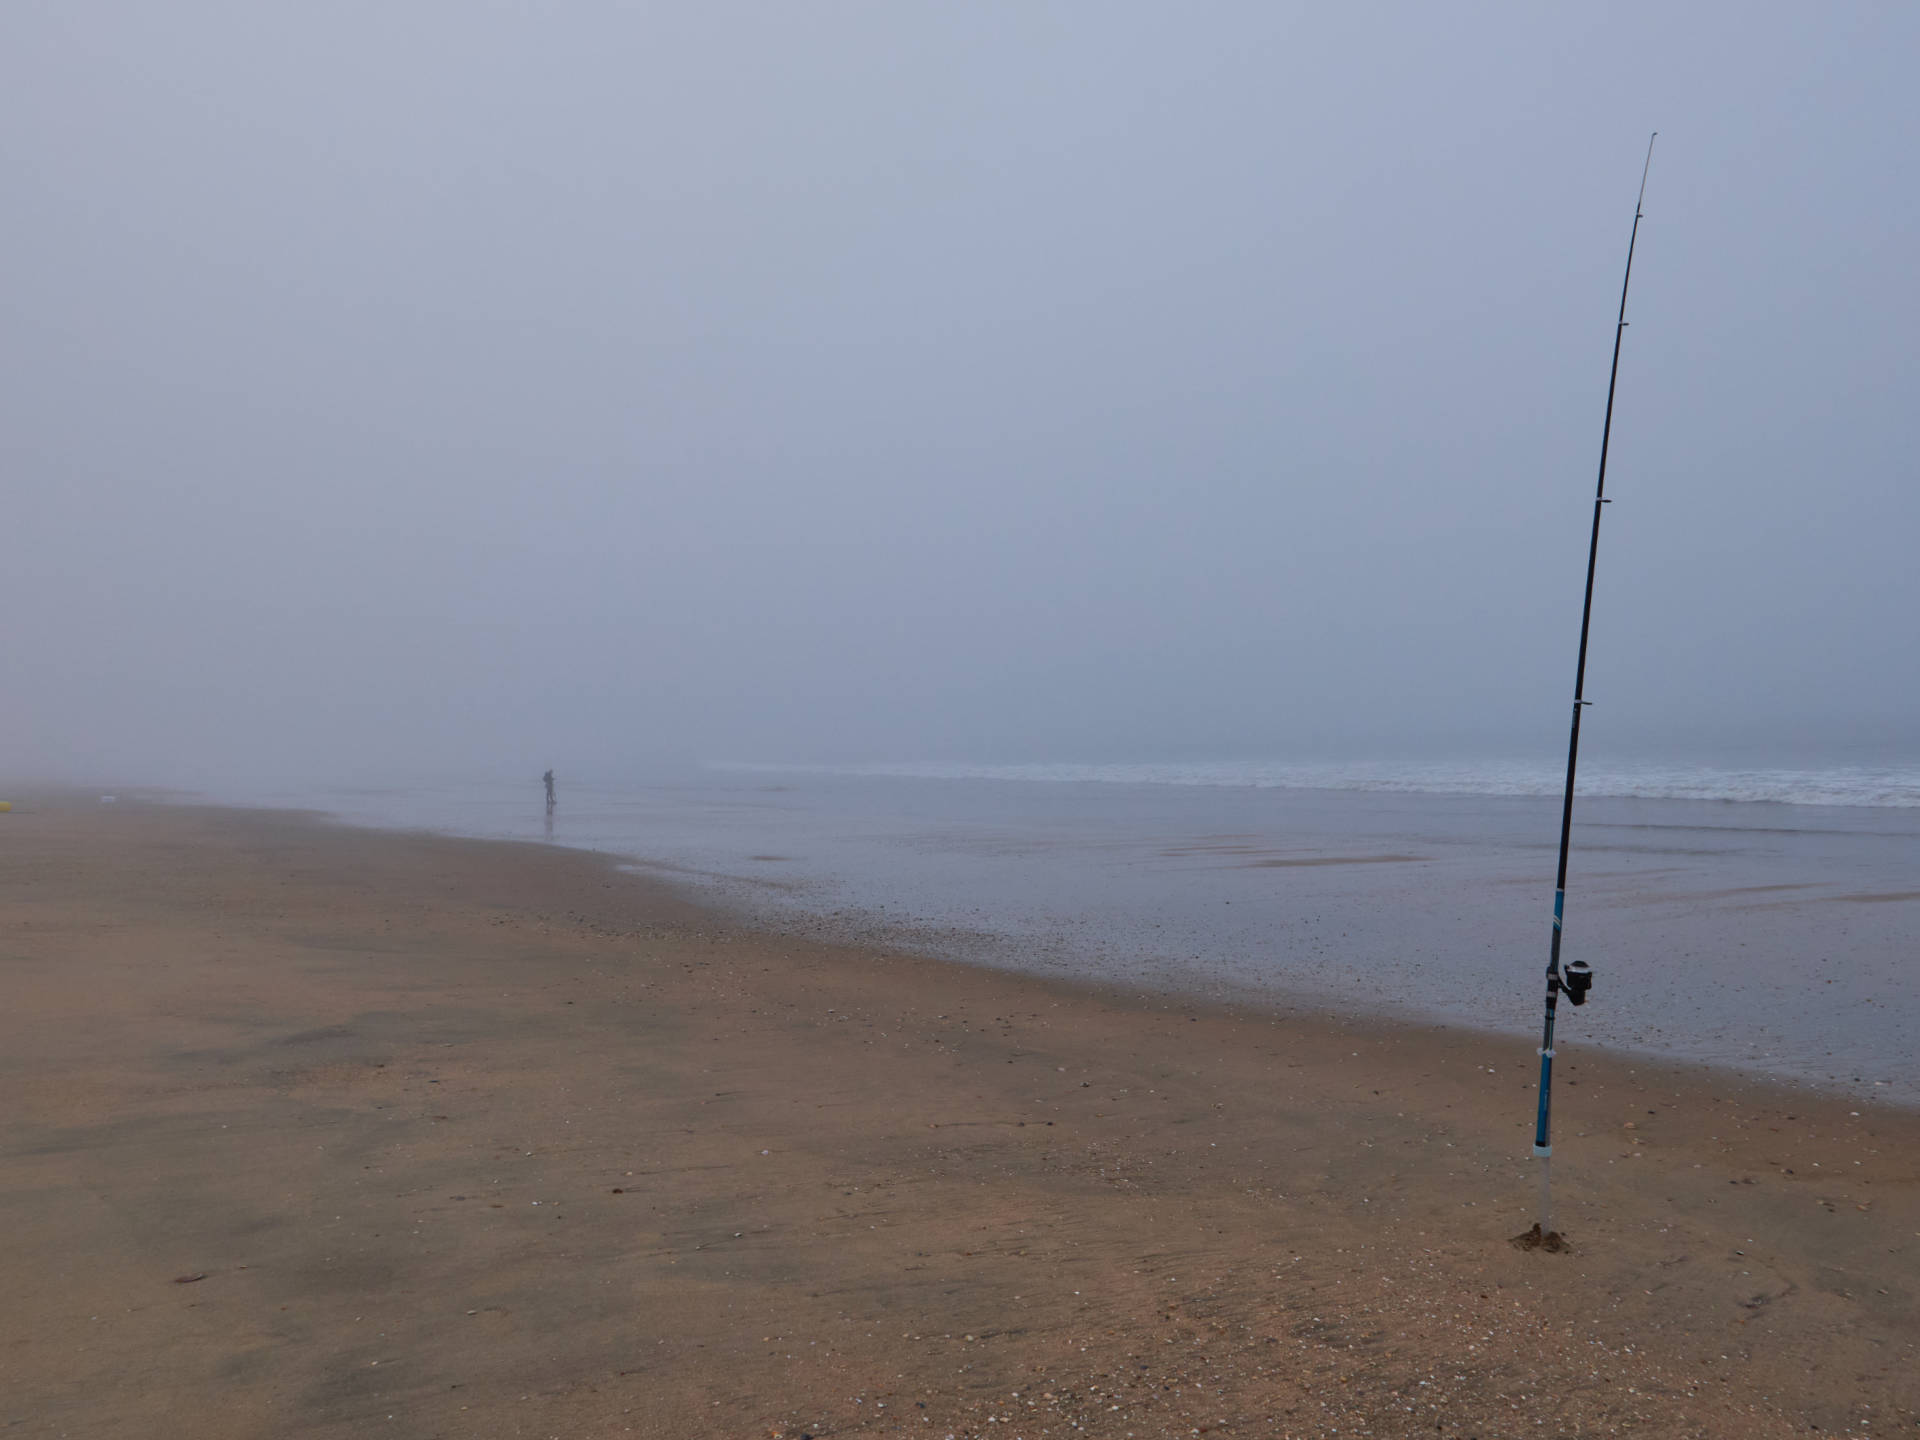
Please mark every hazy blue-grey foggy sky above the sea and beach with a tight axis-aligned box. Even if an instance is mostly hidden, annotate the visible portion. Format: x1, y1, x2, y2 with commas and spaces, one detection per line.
0, 0, 1920, 781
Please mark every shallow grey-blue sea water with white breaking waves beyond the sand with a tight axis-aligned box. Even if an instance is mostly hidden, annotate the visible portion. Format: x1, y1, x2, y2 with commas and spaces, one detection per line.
198, 762, 1920, 1104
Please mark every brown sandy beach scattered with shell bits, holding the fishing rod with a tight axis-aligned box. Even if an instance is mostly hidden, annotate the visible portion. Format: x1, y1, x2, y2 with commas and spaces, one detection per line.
0, 795, 1920, 1440
